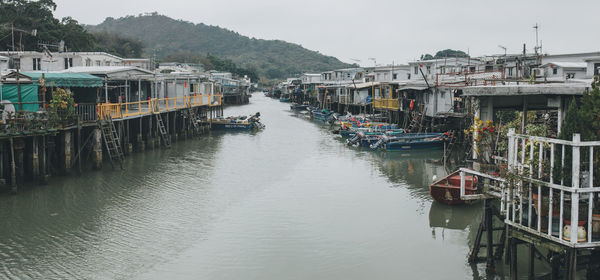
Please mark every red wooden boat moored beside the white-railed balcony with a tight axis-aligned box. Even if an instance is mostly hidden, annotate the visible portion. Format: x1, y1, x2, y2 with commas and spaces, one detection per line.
429, 171, 477, 205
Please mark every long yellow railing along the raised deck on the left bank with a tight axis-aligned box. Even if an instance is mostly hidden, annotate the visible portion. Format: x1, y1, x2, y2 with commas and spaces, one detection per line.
97, 94, 222, 120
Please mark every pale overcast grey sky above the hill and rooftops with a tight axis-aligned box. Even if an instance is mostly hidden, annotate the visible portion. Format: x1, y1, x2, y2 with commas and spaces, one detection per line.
55, 0, 600, 65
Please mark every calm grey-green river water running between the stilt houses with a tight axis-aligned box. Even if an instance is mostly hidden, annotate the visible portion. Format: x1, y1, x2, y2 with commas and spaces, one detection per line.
0, 93, 490, 279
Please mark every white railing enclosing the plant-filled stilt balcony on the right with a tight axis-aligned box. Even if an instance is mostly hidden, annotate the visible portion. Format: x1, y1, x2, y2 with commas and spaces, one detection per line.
461, 129, 600, 247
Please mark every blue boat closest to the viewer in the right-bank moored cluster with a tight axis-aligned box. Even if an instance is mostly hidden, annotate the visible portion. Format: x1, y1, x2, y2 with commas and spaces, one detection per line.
371, 133, 446, 151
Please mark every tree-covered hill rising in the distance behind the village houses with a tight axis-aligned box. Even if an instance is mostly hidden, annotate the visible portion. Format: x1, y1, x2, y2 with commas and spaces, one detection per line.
87, 13, 350, 78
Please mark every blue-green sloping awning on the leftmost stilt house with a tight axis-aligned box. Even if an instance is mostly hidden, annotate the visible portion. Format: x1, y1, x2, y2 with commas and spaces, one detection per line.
23, 72, 102, 87
